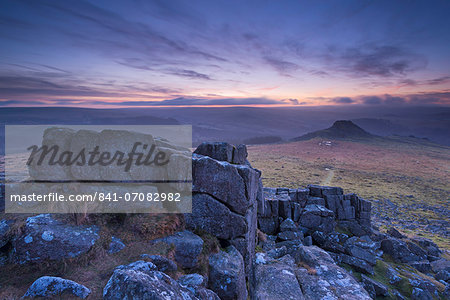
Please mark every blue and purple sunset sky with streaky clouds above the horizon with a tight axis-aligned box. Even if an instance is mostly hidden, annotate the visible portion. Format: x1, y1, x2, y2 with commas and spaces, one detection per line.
0, 0, 450, 107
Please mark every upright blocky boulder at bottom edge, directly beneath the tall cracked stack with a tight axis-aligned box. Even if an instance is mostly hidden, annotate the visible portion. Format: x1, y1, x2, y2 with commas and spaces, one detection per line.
208, 246, 247, 300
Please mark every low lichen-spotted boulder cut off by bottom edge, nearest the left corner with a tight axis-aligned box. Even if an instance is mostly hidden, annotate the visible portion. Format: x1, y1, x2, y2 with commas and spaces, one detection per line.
23, 276, 91, 299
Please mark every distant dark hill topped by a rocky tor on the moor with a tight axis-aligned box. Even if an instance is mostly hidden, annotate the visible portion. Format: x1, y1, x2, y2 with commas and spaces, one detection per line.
292, 120, 376, 141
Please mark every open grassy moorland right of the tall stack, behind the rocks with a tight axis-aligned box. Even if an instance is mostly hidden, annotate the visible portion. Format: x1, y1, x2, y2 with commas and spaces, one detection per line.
248, 138, 450, 249
